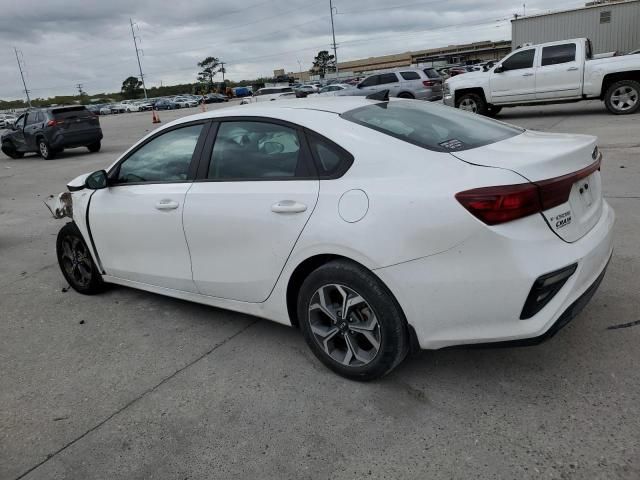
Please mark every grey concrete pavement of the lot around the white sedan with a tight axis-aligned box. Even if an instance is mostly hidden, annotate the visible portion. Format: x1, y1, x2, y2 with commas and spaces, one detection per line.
0, 102, 640, 480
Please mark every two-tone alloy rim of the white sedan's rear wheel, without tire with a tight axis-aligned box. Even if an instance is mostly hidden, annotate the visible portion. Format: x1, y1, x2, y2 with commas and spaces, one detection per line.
308, 284, 382, 367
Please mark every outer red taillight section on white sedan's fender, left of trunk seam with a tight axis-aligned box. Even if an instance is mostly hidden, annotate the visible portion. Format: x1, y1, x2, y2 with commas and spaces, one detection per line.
456, 183, 540, 225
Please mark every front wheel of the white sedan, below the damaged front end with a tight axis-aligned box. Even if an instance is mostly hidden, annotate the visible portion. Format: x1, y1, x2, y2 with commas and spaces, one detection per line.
56, 222, 104, 295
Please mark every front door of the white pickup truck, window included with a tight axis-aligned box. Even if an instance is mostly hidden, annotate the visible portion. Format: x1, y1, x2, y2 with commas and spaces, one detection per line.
490, 48, 536, 104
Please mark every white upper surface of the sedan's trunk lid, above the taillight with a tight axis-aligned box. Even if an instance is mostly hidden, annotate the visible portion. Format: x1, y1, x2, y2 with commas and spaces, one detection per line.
453, 130, 597, 182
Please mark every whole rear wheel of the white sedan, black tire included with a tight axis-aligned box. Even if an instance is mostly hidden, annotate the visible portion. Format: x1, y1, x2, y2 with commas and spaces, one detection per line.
297, 260, 409, 381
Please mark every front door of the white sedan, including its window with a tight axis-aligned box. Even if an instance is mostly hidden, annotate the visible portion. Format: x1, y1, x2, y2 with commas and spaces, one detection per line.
89, 123, 207, 292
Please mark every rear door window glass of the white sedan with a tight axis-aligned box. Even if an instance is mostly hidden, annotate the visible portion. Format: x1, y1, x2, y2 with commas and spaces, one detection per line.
207, 121, 304, 180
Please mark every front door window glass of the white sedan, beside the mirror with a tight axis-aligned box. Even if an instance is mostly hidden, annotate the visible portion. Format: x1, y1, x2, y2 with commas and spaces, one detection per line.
116, 124, 203, 183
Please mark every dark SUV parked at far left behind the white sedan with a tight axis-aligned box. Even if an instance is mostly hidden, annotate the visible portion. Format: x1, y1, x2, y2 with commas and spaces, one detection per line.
1, 106, 102, 160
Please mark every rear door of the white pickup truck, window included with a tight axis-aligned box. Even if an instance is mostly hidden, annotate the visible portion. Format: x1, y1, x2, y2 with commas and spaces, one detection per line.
536, 42, 584, 100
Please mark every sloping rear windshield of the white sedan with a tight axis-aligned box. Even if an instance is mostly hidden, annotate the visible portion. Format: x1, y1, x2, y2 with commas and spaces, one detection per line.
341, 101, 524, 152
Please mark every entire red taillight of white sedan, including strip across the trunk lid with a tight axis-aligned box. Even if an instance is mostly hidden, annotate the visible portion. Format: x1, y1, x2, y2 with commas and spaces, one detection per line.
456, 154, 602, 225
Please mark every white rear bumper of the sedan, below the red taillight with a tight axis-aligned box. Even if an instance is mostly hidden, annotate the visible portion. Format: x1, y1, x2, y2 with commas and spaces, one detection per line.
375, 202, 615, 349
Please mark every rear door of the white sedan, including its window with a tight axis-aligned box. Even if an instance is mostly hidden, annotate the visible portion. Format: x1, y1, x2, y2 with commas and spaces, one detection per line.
184, 119, 319, 302
